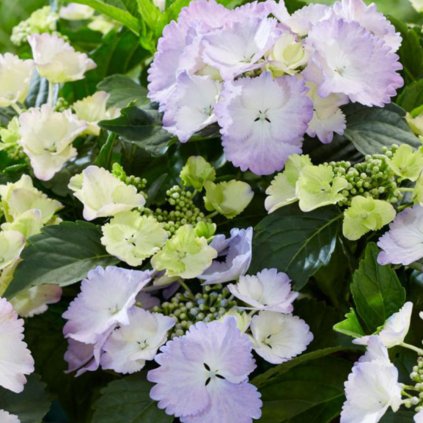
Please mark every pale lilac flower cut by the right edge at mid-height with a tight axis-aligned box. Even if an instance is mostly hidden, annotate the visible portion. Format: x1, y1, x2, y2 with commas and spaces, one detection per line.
377, 205, 423, 266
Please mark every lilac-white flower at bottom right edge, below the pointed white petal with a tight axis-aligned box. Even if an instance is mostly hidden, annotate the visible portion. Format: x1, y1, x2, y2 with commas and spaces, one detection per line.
341, 337, 402, 423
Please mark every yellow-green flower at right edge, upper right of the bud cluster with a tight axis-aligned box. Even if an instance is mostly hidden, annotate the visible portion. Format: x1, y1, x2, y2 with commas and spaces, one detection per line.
388, 144, 423, 181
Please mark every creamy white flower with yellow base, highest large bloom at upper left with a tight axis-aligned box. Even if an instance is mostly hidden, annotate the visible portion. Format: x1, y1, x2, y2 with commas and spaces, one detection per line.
28, 33, 97, 83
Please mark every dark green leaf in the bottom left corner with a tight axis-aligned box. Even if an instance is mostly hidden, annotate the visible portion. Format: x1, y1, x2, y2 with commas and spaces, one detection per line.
0, 374, 51, 423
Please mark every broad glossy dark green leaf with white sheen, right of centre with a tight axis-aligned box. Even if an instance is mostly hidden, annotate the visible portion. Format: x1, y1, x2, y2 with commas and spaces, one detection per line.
250, 204, 342, 289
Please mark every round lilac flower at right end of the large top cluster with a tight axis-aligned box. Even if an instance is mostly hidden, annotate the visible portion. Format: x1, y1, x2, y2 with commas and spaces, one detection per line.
306, 17, 403, 107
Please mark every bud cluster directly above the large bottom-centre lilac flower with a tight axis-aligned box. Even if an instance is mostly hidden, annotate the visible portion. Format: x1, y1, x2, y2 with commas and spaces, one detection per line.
152, 284, 236, 338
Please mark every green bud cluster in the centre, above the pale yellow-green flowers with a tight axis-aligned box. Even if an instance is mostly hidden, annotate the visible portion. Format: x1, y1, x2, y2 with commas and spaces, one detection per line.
154, 185, 211, 235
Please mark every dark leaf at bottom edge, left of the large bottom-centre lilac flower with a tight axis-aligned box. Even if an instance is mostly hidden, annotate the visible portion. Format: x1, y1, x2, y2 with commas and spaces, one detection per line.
91, 373, 173, 423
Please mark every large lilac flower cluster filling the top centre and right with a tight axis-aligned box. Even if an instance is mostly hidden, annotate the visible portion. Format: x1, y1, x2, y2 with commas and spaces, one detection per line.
149, 0, 403, 175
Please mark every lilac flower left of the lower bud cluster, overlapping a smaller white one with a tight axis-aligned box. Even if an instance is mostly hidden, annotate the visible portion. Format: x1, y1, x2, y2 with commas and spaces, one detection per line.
63, 266, 151, 344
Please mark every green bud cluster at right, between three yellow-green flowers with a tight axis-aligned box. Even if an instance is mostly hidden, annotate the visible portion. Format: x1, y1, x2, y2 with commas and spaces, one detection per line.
328, 146, 402, 206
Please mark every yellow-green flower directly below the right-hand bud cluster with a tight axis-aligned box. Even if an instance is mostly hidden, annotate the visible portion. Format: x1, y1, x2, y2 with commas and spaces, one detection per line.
342, 195, 396, 241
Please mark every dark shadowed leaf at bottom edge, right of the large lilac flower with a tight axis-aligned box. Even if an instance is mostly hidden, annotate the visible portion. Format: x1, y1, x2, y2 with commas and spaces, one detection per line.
253, 358, 351, 423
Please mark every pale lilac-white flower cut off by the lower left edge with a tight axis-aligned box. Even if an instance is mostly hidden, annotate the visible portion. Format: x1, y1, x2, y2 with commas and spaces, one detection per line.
0, 298, 34, 393
